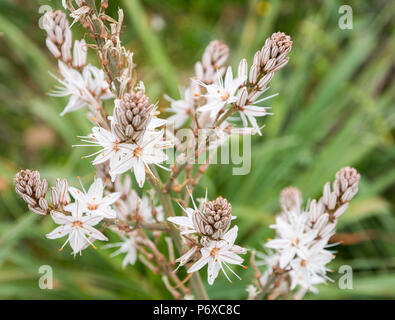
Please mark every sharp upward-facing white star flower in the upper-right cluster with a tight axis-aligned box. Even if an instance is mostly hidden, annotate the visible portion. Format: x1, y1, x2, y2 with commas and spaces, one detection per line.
198, 67, 245, 119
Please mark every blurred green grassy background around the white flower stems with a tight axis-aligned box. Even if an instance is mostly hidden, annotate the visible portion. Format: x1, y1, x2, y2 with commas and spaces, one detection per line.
0, 0, 395, 299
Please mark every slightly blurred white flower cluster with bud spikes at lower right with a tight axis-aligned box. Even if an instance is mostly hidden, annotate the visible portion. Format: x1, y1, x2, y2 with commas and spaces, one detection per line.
261, 167, 360, 292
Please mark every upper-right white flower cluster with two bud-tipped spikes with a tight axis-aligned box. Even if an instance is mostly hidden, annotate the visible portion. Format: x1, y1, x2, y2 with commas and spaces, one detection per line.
166, 32, 292, 144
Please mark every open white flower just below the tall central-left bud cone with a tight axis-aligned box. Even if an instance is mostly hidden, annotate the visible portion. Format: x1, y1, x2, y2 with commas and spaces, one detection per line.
110, 133, 169, 188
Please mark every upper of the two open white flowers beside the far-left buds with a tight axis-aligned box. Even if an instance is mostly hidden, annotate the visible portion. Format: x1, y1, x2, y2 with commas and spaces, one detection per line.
69, 178, 121, 219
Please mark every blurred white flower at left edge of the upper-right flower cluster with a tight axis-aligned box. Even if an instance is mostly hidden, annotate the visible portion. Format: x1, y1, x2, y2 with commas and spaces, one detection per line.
165, 88, 193, 129
